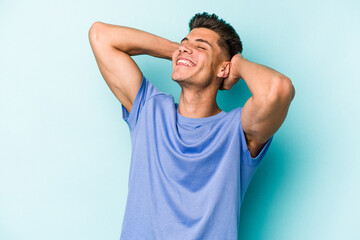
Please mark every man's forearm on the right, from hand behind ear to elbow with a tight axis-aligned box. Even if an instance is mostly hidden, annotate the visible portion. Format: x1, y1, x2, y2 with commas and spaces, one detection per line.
236, 58, 294, 100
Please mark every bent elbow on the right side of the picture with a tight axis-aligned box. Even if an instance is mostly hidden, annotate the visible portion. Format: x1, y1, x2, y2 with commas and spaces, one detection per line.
268, 76, 295, 104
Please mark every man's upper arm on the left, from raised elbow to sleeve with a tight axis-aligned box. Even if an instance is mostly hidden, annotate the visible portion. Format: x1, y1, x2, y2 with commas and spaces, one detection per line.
89, 22, 142, 112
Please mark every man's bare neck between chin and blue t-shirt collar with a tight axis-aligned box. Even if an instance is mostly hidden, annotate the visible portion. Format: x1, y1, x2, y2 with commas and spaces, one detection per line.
178, 89, 222, 118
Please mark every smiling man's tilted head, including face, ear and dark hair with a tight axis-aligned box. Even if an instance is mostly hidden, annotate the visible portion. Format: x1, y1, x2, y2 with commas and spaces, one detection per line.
172, 12, 242, 89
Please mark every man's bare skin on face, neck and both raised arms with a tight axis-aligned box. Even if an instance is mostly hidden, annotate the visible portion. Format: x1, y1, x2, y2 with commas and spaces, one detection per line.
89, 22, 295, 157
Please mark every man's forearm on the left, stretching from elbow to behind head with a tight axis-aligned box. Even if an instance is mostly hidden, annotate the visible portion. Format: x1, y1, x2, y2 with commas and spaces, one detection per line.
90, 22, 179, 60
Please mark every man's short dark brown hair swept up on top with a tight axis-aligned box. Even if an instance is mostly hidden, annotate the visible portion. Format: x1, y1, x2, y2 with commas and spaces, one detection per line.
189, 12, 243, 59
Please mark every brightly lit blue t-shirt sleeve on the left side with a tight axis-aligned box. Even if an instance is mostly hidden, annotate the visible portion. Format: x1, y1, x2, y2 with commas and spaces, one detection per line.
121, 75, 161, 131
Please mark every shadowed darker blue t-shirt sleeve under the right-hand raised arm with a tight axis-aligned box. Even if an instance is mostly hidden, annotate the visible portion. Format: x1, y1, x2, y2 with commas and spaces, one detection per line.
239, 108, 274, 198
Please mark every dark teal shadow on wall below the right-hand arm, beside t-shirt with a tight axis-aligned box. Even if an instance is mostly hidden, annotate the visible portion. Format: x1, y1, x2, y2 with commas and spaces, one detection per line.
239, 134, 296, 240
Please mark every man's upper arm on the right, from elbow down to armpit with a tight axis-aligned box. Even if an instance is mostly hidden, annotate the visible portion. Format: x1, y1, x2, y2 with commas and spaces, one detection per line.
241, 78, 295, 157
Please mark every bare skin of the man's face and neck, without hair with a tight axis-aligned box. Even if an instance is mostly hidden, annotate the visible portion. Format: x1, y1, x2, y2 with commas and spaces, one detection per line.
171, 28, 230, 118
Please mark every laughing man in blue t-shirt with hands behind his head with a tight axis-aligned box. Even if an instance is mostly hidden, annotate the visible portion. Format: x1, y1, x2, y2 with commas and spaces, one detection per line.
89, 13, 295, 240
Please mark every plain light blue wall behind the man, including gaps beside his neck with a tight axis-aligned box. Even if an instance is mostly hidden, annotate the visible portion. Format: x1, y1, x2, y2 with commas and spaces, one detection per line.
0, 0, 360, 240
